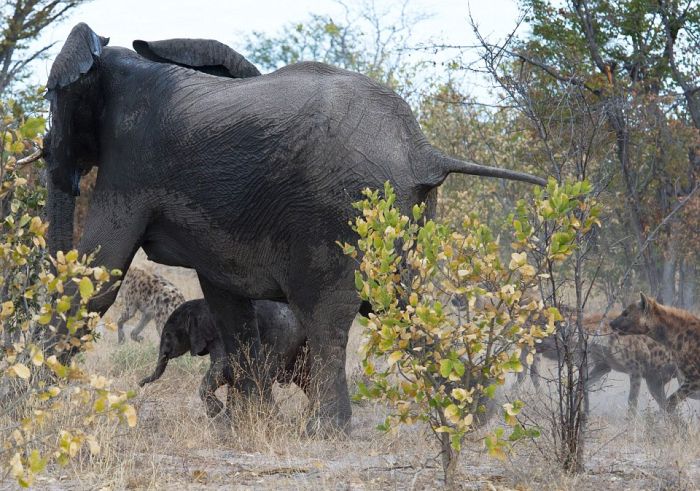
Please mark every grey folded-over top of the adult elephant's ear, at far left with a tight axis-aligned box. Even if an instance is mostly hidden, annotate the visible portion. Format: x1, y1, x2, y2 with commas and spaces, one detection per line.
46, 22, 109, 94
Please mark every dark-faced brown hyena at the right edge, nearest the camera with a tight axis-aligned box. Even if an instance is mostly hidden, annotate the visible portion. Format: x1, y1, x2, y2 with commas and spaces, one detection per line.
610, 293, 700, 411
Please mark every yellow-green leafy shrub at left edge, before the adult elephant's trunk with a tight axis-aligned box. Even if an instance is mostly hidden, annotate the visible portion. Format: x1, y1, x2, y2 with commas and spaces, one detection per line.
0, 103, 136, 487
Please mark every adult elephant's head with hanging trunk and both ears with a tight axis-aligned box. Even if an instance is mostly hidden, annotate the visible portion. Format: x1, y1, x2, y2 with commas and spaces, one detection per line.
44, 22, 260, 253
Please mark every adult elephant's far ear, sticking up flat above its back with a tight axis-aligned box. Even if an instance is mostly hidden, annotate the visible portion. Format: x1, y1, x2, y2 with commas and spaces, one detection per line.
133, 39, 260, 78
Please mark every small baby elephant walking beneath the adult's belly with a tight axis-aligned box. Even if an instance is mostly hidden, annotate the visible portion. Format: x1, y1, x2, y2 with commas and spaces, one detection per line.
139, 299, 309, 418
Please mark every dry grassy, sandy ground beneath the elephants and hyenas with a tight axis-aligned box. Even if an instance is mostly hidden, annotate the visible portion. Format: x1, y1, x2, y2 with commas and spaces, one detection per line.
6, 254, 700, 490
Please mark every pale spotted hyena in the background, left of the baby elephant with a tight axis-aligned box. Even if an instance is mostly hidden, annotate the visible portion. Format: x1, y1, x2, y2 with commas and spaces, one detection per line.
117, 266, 185, 343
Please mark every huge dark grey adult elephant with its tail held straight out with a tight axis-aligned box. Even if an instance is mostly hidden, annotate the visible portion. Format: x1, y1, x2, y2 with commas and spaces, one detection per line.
47, 24, 543, 429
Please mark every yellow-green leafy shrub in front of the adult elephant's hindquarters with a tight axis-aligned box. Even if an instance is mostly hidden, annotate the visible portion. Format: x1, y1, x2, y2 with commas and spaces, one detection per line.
342, 181, 594, 486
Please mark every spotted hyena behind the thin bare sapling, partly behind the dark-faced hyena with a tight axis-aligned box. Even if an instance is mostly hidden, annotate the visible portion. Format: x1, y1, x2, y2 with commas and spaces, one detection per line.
518, 314, 678, 412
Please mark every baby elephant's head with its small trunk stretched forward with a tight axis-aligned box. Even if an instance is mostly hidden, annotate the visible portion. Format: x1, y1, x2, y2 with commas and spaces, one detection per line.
139, 300, 217, 387
